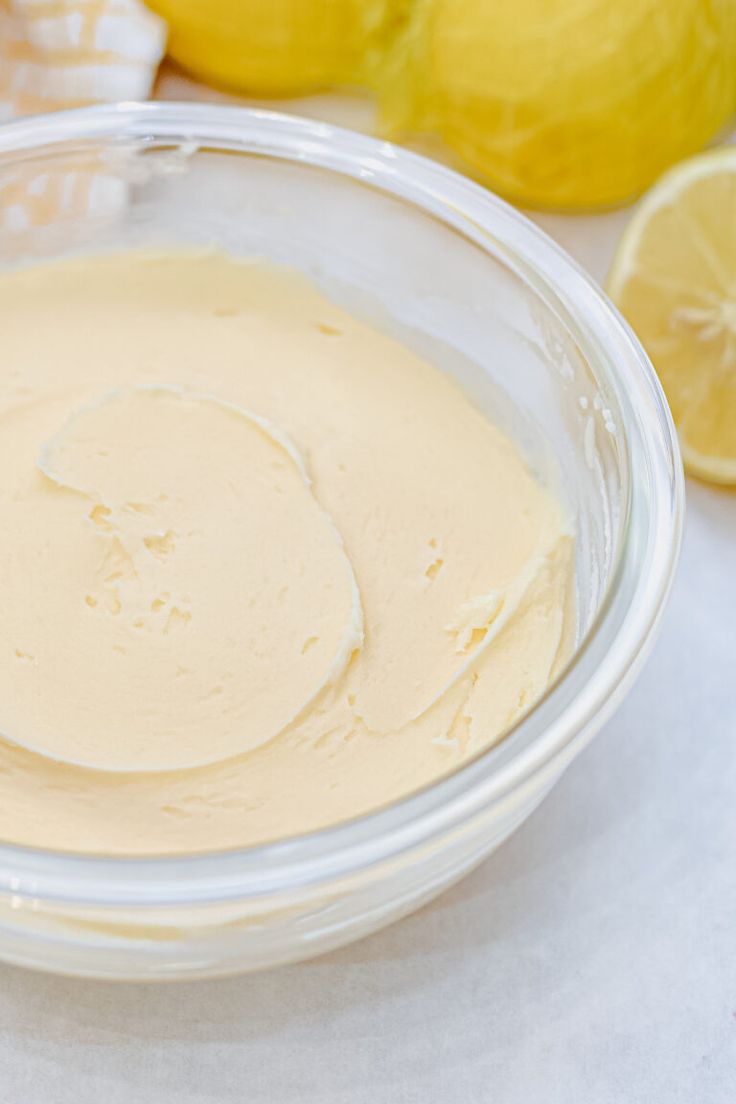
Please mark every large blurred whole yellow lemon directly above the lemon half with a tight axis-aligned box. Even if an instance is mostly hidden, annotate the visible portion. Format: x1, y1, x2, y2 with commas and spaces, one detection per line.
383, 0, 736, 209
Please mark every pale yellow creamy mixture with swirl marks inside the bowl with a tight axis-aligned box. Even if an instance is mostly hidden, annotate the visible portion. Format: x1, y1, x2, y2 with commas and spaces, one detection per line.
0, 253, 572, 853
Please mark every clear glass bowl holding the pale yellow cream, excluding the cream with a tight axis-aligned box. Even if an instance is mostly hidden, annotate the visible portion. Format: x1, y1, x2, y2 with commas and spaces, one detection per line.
0, 104, 683, 980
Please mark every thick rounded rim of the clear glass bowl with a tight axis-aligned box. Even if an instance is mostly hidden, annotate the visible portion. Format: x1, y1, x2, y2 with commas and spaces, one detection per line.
0, 103, 684, 906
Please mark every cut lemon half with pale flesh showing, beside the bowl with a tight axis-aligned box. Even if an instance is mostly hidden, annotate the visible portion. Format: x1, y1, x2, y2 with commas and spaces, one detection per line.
607, 147, 736, 484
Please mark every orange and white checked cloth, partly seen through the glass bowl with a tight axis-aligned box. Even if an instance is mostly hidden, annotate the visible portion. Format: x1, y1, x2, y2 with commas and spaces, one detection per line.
0, 0, 167, 235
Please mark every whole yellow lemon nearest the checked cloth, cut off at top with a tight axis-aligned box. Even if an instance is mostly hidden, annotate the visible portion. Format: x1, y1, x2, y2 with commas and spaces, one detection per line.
149, 0, 407, 96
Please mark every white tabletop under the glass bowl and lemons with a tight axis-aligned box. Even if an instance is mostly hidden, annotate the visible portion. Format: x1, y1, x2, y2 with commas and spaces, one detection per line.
0, 76, 736, 1104
